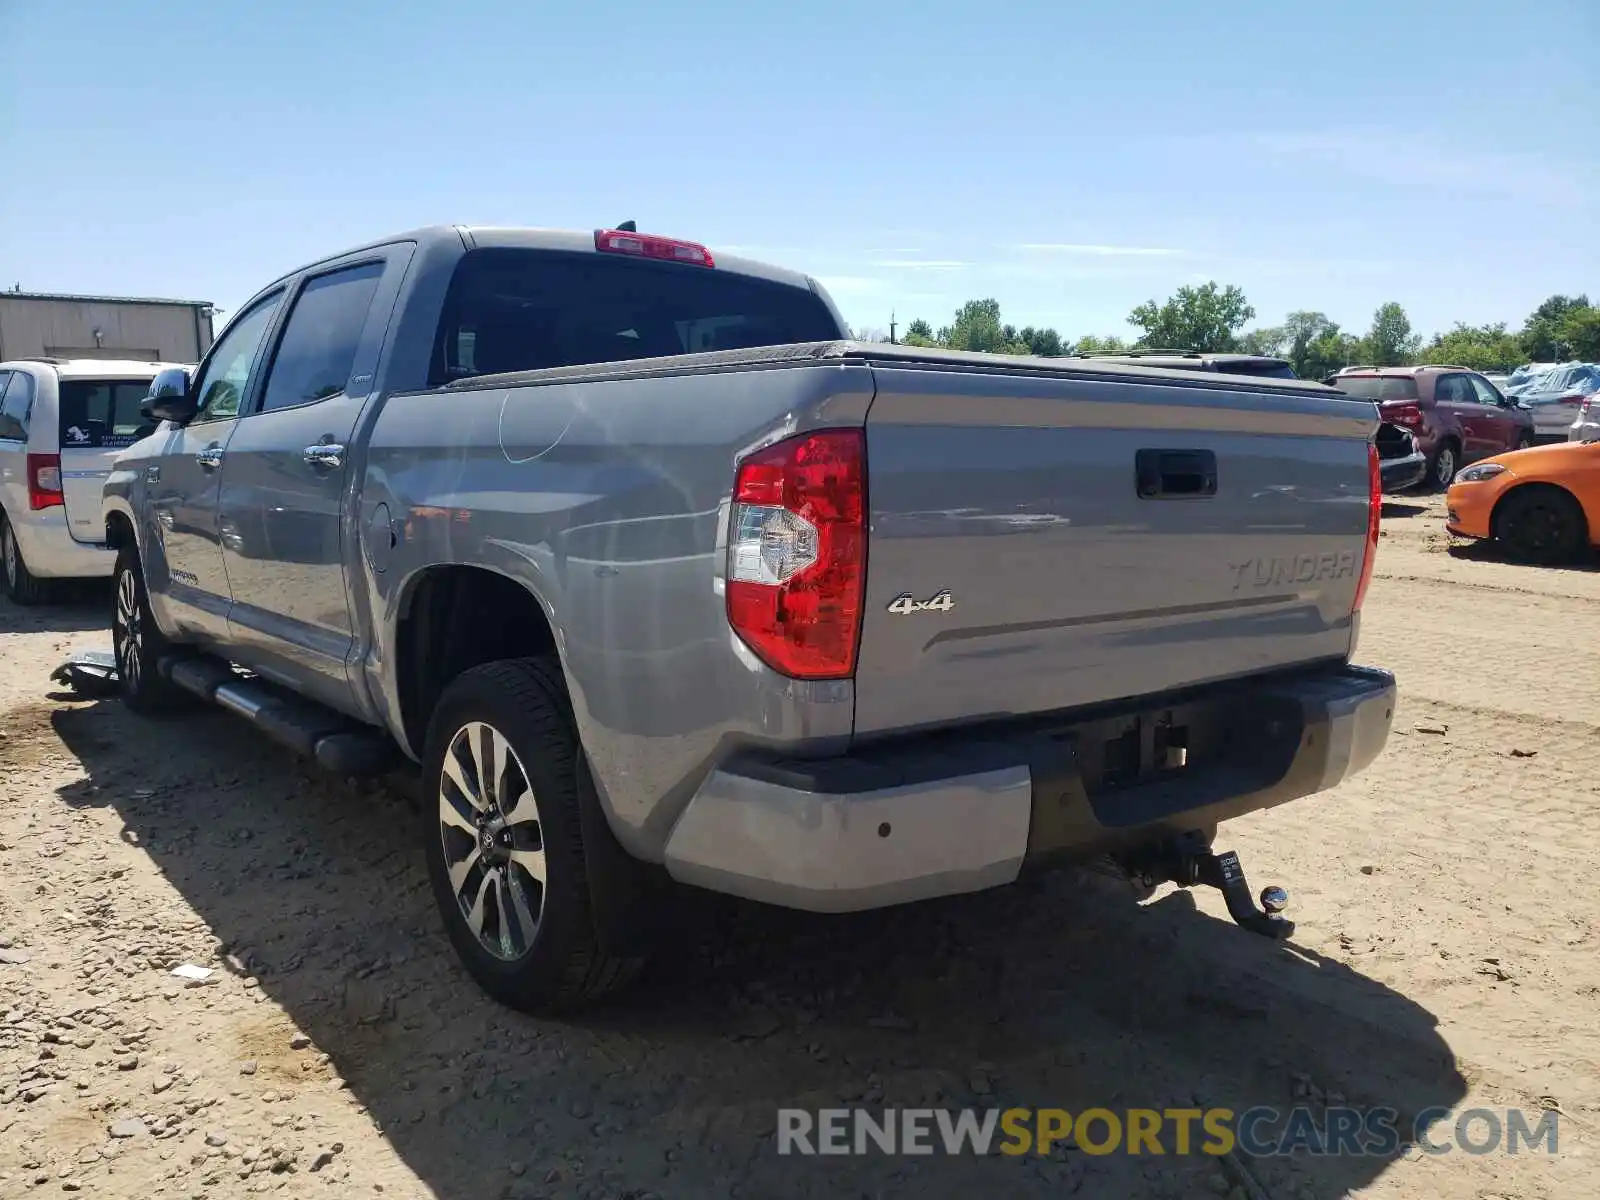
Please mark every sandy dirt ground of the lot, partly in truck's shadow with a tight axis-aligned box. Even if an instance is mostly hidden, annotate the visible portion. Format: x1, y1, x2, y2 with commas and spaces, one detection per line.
0, 499, 1600, 1200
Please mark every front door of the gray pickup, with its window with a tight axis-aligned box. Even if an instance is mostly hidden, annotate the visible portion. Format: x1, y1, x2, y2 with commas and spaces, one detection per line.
142, 293, 283, 640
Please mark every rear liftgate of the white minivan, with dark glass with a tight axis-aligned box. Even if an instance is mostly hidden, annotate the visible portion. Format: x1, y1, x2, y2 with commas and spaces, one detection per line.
56, 376, 155, 542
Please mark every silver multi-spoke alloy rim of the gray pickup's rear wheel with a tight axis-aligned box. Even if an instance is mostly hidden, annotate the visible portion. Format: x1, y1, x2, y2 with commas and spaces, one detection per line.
438, 722, 546, 962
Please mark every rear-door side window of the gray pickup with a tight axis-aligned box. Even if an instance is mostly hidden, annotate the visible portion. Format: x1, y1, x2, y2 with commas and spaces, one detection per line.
261, 262, 384, 413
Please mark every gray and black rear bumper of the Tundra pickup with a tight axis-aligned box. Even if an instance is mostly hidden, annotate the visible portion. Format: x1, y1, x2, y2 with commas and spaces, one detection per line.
664, 667, 1395, 912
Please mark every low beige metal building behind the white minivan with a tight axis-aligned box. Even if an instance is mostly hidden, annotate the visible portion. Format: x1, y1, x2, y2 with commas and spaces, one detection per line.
0, 291, 216, 363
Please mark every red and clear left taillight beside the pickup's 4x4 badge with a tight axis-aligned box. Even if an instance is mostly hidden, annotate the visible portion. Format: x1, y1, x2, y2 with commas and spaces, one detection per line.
728, 429, 867, 678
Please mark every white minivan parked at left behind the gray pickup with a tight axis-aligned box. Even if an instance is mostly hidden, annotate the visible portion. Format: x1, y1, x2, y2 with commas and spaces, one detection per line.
0, 358, 179, 605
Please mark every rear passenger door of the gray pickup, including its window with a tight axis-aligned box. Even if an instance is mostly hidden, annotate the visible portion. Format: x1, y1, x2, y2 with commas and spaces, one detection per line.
221, 251, 402, 710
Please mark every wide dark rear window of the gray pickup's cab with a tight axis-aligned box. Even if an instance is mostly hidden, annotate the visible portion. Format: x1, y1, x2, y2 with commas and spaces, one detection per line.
429, 250, 842, 384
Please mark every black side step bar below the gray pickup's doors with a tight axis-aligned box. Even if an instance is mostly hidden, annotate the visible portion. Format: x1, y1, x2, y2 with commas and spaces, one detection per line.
157, 654, 400, 778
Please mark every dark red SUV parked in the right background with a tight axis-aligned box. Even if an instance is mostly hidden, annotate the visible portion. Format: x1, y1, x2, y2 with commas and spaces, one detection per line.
1333, 366, 1533, 490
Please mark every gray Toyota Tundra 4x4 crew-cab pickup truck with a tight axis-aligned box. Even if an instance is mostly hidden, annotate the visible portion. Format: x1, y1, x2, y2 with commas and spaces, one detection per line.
104, 226, 1395, 1011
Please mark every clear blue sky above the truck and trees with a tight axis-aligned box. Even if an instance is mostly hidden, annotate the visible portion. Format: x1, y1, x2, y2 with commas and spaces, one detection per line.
0, 0, 1600, 345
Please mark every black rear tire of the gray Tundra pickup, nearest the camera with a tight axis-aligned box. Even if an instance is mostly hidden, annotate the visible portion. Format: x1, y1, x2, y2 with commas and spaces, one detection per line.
422, 658, 642, 1013
